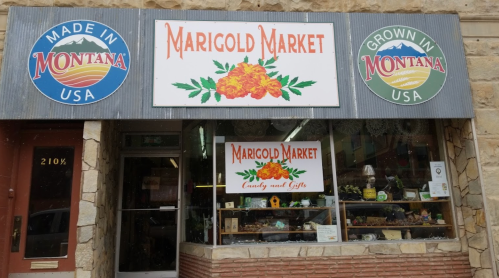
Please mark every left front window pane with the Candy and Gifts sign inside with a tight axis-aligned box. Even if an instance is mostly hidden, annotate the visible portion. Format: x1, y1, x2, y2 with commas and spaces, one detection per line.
215, 120, 338, 245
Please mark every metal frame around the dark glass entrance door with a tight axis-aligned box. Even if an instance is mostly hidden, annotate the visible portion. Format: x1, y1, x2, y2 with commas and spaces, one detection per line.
114, 152, 183, 278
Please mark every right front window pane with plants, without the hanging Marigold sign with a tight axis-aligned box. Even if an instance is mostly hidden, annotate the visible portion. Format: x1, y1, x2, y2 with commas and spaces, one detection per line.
333, 119, 455, 241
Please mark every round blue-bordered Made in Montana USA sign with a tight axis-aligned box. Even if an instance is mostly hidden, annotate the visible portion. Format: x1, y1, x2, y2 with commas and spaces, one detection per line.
28, 20, 130, 105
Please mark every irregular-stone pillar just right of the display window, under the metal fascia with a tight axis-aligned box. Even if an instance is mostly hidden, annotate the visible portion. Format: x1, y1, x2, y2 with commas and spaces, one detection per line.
444, 120, 493, 277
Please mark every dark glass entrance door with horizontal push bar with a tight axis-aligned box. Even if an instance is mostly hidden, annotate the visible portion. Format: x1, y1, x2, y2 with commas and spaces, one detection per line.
117, 155, 181, 278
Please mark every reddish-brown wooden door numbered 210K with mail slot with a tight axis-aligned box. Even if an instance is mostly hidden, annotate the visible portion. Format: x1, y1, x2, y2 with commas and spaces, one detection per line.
9, 130, 83, 277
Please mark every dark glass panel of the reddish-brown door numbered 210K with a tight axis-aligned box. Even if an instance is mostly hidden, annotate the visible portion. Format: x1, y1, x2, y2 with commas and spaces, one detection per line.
25, 147, 74, 258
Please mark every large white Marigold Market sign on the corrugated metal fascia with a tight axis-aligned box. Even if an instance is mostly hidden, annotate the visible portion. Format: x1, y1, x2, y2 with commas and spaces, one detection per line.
153, 20, 339, 107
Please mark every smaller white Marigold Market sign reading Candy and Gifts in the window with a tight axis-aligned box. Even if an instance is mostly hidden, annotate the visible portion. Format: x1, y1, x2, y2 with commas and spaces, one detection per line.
225, 142, 324, 193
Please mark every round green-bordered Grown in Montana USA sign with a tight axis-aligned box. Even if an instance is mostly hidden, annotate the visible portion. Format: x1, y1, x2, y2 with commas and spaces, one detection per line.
358, 26, 447, 105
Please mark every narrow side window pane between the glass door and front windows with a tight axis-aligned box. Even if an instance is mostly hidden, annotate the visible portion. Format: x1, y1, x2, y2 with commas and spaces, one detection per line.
182, 121, 213, 244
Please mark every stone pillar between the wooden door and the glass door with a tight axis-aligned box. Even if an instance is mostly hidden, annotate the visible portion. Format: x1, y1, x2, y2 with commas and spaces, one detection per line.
75, 121, 120, 278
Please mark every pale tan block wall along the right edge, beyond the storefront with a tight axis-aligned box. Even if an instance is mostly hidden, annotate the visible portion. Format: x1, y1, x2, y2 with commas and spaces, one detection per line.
462, 13, 499, 275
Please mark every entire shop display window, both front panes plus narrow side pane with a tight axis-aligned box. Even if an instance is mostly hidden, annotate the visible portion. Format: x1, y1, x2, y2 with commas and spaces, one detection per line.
183, 119, 455, 245
